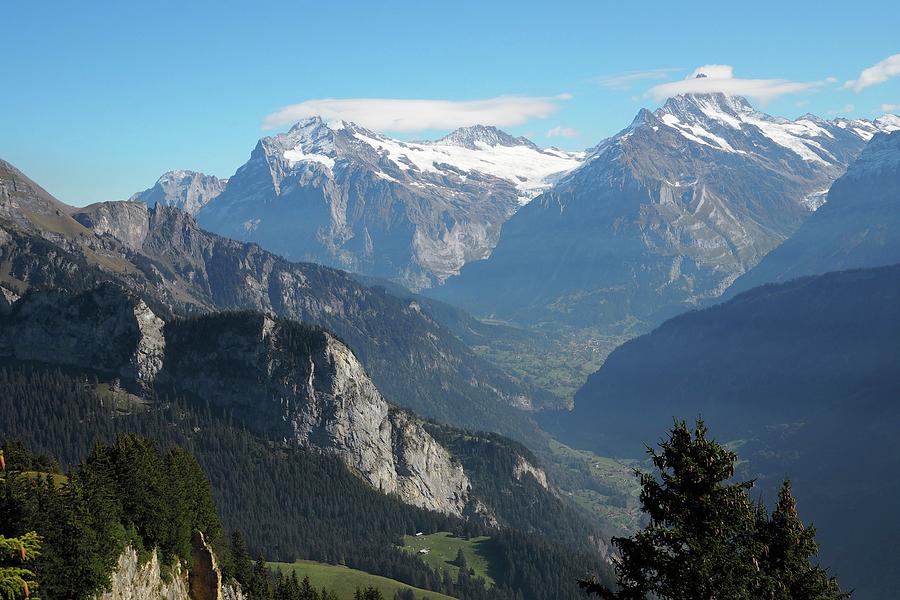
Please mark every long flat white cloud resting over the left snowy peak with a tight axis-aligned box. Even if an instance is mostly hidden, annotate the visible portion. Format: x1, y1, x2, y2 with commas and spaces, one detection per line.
263, 94, 572, 131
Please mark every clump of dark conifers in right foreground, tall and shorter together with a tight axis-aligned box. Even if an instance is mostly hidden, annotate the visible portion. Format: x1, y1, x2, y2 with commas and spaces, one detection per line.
579, 419, 848, 600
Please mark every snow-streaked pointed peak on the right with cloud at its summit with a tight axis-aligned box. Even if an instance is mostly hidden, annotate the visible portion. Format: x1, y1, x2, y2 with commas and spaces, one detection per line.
429, 93, 900, 329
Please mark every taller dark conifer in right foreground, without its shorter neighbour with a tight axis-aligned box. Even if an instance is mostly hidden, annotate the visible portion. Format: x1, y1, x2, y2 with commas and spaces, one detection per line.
581, 419, 762, 600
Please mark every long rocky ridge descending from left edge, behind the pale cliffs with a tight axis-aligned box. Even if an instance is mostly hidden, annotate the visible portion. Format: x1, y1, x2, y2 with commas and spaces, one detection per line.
0, 159, 546, 443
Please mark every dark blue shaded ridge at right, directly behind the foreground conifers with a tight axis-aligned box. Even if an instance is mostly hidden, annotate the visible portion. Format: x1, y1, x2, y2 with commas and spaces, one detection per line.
554, 265, 900, 600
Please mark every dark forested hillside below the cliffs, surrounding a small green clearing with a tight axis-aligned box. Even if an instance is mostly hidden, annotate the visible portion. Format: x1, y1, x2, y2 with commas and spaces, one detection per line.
0, 364, 607, 600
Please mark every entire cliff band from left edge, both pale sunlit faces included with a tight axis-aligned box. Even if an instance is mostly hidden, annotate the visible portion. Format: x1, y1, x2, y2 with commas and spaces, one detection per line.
0, 284, 470, 515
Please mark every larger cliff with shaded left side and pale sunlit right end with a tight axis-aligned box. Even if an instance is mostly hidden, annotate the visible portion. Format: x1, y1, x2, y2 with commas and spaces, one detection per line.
160, 314, 471, 515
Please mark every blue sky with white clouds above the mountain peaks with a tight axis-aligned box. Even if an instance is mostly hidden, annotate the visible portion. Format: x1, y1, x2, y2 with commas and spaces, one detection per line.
0, 0, 900, 205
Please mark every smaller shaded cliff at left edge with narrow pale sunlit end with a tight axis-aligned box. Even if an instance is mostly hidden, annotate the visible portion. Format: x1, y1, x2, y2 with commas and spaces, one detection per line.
0, 284, 165, 382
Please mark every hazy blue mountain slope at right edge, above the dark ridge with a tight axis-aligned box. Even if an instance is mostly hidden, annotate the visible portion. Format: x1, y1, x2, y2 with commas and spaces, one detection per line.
728, 131, 900, 296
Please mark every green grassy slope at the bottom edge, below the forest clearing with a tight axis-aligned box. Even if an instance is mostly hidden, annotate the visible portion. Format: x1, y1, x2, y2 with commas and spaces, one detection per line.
269, 560, 453, 600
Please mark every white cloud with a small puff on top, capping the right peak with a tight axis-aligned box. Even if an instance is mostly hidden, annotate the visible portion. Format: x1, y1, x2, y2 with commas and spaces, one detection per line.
647, 65, 825, 104
